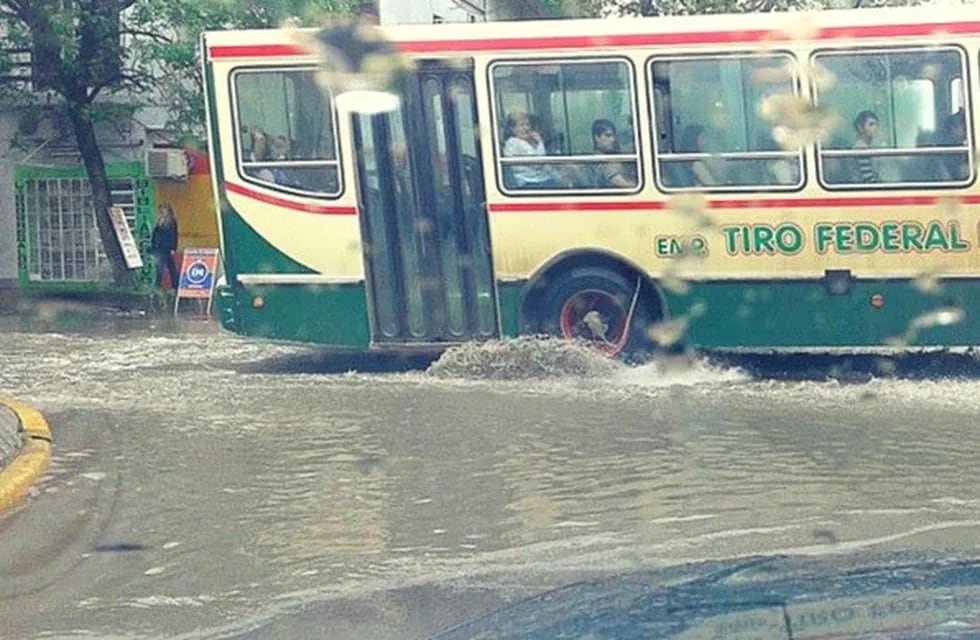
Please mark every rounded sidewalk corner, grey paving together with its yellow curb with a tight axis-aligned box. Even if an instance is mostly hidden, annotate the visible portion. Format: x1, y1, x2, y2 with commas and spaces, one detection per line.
0, 396, 51, 512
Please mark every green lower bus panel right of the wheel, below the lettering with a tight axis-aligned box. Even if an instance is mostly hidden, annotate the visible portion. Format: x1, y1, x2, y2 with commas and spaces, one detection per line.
666, 280, 980, 349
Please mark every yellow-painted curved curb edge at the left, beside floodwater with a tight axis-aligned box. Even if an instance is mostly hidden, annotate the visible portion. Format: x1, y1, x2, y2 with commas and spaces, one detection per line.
0, 396, 51, 512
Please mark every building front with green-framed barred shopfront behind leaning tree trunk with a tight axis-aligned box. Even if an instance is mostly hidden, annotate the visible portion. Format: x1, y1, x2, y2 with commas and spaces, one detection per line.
0, 107, 154, 291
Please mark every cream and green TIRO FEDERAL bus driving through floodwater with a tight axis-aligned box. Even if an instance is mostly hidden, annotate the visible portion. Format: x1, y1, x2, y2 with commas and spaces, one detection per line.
203, 5, 980, 354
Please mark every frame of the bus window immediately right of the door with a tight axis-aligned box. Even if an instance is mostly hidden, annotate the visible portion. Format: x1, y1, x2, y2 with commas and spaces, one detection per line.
486, 55, 646, 198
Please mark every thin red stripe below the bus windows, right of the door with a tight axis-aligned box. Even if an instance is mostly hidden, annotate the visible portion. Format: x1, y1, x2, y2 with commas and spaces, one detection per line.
489, 196, 948, 213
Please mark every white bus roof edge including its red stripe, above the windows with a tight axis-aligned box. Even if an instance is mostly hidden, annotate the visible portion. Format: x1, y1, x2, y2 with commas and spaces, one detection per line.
204, 5, 980, 59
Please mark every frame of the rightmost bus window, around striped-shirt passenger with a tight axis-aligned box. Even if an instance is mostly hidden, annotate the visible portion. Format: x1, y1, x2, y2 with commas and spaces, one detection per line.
809, 43, 977, 191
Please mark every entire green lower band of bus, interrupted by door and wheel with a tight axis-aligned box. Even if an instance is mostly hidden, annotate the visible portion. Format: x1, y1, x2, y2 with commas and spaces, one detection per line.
216, 280, 980, 349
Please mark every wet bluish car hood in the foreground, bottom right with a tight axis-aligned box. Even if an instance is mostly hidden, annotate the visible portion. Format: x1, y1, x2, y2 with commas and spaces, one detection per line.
437, 554, 980, 640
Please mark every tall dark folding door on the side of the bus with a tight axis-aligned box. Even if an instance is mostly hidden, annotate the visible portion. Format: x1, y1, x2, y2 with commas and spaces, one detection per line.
351, 61, 499, 347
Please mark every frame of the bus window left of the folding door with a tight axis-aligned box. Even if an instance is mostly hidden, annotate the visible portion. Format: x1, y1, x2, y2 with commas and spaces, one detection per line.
228, 64, 346, 200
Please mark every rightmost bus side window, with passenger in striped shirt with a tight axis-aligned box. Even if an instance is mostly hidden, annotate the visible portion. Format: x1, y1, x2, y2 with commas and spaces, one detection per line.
813, 46, 974, 189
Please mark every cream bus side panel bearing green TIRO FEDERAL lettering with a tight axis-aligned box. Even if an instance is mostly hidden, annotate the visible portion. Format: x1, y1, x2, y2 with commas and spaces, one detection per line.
491, 201, 980, 280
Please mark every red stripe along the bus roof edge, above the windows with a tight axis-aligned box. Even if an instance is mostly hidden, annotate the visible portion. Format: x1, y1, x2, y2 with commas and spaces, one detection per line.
209, 21, 980, 58
